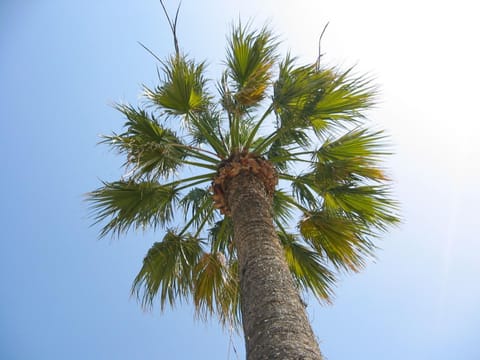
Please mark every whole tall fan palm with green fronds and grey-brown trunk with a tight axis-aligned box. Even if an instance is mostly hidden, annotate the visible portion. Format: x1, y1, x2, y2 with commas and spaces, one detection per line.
89, 18, 398, 360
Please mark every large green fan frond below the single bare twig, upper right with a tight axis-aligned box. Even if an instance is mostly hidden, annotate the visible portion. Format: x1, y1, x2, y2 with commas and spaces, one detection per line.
273, 55, 376, 136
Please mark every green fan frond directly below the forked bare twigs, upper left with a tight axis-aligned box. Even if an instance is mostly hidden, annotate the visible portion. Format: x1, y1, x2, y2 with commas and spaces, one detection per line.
145, 55, 210, 115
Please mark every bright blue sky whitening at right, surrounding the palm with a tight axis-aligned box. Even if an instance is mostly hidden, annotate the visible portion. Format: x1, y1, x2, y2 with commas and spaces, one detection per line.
0, 0, 480, 360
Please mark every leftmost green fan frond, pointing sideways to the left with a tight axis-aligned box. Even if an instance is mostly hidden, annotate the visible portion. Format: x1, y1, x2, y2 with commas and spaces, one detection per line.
87, 181, 178, 237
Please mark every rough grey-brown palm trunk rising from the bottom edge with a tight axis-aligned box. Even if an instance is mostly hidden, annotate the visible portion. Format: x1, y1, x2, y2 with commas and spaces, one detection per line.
226, 172, 322, 360
